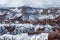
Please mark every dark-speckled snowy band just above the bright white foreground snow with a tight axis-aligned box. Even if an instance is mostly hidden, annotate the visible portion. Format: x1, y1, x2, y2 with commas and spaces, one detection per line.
0, 24, 53, 35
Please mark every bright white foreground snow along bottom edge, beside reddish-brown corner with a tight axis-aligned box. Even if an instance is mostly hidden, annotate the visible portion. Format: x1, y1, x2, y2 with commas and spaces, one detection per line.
0, 33, 48, 40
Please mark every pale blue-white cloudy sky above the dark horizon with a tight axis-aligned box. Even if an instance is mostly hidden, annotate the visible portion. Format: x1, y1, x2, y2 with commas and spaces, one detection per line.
0, 0, 60, 8
